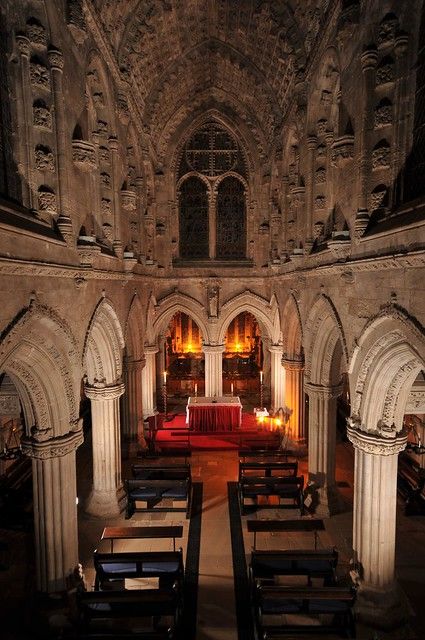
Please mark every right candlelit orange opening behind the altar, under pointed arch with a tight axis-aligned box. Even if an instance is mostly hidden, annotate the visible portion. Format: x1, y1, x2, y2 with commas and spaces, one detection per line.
223, 311, 262, 405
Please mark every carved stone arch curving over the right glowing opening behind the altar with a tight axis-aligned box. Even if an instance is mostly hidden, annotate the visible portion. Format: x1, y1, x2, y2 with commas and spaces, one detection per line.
217, 291, 281, 344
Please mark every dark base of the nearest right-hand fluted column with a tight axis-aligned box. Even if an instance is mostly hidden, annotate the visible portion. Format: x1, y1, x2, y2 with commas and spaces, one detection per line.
355, 581, 409, 637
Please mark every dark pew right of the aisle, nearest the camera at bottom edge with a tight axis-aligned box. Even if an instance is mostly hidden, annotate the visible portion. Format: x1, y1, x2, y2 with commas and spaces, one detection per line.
253, 585, 356, 640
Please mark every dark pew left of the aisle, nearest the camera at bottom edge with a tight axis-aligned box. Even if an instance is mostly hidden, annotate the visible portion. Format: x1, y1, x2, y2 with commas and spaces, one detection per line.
77, 589, 182, 640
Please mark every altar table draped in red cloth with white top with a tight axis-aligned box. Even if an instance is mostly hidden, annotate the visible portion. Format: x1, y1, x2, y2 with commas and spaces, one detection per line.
186, 396, 242, 433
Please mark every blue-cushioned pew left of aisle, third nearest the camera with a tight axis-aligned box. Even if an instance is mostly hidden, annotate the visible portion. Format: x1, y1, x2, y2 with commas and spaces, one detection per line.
124, 471, 192, 519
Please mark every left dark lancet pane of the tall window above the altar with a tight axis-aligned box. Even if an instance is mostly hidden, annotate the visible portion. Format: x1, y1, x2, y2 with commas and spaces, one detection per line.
179, 176, 209, 260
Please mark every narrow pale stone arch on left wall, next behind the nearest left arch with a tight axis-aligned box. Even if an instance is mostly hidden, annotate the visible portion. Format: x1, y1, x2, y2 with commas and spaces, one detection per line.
83, 298, 125, 385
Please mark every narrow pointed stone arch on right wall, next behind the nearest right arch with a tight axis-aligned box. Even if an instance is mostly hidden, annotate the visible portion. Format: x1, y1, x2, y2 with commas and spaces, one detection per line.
304, 295, 348, 385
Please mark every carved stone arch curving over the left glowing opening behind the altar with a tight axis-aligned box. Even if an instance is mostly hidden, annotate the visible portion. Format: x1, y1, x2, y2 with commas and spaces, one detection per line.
147, 291, 210, 344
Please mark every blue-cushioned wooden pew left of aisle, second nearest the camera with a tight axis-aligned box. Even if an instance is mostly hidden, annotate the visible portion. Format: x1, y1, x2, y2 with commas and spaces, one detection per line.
93, 549, 184, 591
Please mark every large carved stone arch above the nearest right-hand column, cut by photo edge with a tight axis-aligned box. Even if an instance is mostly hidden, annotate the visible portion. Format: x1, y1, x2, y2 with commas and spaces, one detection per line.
349, 306, 425, 433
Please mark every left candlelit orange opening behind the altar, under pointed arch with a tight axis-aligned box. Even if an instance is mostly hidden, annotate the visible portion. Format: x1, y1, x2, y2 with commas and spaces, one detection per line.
161, 311, 205, 408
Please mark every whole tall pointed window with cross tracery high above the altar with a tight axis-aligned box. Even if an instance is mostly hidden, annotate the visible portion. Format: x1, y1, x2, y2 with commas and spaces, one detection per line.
177, 120, 247, 260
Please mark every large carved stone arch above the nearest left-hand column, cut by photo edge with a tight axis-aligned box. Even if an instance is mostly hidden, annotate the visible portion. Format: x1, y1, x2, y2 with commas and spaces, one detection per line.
0, 300, 81, 439
